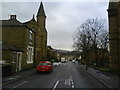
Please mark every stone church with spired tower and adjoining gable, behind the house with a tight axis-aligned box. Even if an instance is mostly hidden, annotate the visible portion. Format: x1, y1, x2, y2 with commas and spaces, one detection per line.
25, 2, 47, 64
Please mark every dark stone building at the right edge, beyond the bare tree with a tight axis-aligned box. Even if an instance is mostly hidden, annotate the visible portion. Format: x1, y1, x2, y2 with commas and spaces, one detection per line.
108, 1, 120, 75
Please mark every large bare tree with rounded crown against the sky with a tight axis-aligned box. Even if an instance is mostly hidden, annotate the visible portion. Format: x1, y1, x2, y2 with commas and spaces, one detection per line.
73, 18, 108, 65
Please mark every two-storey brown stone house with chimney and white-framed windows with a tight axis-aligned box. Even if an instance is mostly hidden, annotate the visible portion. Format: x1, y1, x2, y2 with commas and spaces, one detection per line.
0, 15, 35, 72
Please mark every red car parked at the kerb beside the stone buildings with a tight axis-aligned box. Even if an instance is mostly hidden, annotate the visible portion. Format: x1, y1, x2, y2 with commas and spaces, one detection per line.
36, 61, 53, 72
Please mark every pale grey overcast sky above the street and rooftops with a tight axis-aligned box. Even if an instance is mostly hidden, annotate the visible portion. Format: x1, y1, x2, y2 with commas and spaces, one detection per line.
0, 0, 108, 50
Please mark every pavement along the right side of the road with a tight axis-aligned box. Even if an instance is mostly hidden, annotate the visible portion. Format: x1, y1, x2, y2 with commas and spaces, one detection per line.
81, 65, 120, 90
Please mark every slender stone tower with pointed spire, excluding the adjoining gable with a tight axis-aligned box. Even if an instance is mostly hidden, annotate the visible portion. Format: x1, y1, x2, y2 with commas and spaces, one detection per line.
36, 2, 47, 59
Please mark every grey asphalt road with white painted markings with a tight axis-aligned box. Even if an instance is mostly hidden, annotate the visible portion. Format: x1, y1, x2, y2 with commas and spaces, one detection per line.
3, 61, 105, 90
